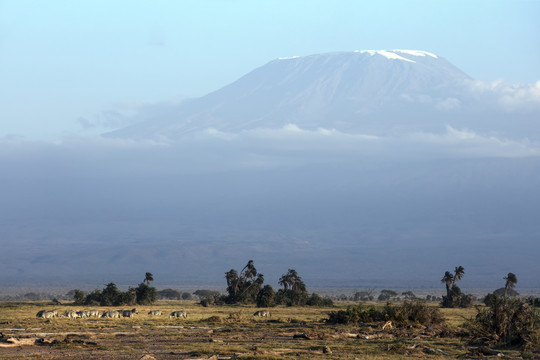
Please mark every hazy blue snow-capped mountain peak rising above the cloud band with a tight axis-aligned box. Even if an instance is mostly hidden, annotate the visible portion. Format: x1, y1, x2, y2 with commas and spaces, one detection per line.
107, 50, 471, 139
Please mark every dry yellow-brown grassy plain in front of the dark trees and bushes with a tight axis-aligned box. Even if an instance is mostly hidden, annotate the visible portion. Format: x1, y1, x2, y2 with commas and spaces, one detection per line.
0, 301, 532, 360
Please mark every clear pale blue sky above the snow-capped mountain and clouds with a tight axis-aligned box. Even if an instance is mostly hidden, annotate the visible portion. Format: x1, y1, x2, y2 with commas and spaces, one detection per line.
0, 0, 540, 140
